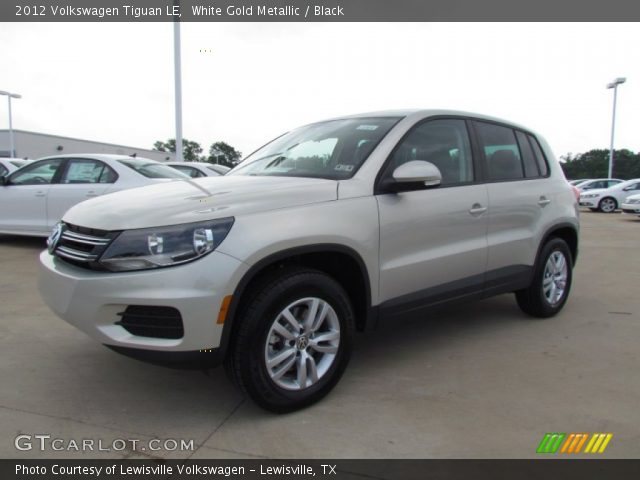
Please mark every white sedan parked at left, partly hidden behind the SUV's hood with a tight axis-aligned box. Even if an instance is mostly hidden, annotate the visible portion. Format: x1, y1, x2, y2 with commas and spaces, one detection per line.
0, 154, 187, 237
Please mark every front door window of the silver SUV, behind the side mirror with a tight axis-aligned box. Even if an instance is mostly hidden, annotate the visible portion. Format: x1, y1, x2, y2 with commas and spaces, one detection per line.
388, 119, 473, 186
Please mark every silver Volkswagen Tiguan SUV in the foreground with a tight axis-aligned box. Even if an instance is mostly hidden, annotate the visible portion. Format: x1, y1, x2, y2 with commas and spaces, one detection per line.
40, 110, 579, 412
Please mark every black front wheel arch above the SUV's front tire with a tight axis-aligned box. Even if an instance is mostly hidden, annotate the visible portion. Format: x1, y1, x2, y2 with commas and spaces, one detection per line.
220, 243, 377, 358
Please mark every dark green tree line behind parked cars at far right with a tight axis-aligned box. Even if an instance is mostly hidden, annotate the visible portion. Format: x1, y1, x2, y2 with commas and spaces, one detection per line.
560, 149, 640, 180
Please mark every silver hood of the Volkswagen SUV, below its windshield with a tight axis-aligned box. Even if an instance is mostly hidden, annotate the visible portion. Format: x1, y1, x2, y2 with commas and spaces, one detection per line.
63, 175, 338, 230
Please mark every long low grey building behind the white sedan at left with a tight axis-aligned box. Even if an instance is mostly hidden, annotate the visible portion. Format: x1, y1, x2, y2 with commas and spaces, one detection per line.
0, 129, 175, 162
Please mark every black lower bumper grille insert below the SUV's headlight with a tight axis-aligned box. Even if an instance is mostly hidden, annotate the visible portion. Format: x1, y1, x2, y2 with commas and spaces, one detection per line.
116, 305, 184, 339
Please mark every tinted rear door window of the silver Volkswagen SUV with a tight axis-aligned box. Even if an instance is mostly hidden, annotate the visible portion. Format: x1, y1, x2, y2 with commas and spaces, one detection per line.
476, 122, 524, 181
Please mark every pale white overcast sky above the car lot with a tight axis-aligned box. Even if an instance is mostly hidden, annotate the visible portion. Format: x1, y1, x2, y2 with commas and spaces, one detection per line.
0, 23, 640, 155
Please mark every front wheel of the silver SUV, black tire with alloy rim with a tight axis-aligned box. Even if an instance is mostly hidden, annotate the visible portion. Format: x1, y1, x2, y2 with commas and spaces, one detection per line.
225, 268, 355, 413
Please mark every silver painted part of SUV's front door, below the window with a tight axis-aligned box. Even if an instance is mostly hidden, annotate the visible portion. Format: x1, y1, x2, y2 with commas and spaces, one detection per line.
377, 185, 488, 302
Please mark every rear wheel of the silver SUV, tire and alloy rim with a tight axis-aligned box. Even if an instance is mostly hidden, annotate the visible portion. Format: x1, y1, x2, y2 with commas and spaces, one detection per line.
516, 237, 573, 318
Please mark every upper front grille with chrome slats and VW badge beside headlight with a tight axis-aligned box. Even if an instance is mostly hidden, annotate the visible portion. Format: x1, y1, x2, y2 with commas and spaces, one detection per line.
52, 223, 120, 270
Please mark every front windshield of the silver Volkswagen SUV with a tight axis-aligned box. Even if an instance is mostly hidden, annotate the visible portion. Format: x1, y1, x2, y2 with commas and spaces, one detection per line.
227, 117, 400, 180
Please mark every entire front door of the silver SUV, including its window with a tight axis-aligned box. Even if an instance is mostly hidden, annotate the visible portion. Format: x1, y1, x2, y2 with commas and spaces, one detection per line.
376, 118, 488, 309
